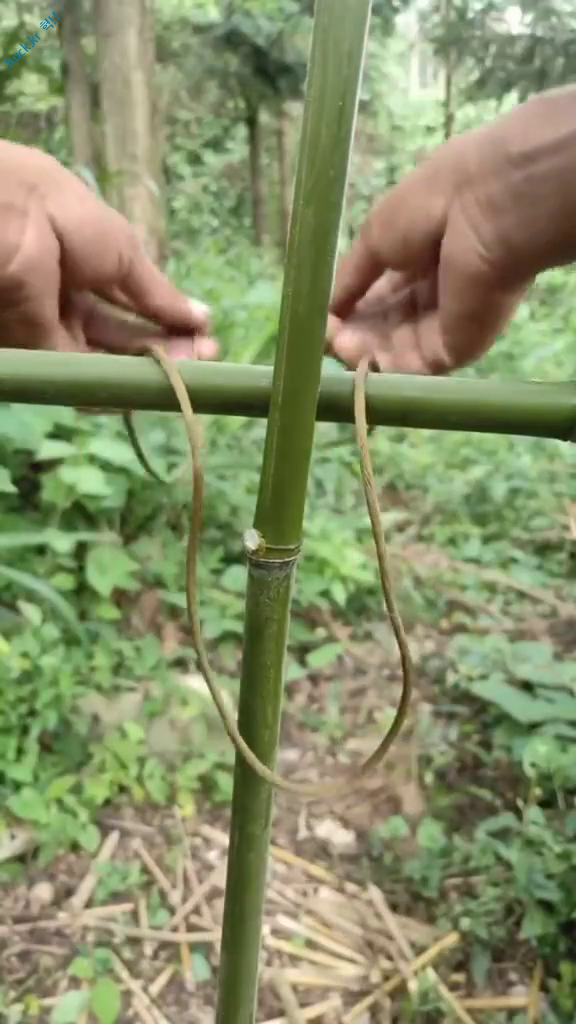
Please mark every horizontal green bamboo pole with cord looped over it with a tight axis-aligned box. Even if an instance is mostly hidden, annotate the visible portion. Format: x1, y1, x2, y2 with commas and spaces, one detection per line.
0, 349, 576, 440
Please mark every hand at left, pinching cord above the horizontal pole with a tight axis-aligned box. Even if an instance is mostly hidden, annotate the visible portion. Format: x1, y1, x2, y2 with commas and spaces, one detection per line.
0, 140, 217, 359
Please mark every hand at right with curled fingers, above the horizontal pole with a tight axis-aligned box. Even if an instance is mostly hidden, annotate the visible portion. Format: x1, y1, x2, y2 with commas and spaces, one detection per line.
328, 86, 576, 374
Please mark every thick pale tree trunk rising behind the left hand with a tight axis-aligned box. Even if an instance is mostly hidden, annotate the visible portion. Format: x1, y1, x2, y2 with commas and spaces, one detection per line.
94, 0, 163, 261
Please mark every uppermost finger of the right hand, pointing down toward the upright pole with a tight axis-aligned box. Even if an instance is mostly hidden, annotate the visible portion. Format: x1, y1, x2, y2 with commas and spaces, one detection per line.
330, 153, 453, 319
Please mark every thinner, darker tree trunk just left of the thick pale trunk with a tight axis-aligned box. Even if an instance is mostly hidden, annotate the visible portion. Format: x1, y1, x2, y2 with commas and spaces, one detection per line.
58, 0, 96, 174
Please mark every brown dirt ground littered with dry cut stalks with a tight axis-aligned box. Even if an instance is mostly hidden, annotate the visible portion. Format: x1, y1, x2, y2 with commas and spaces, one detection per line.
0, 602, 561, 1024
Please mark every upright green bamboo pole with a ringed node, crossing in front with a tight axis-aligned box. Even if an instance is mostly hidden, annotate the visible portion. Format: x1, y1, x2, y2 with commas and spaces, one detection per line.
216, 0, 371, 1024
